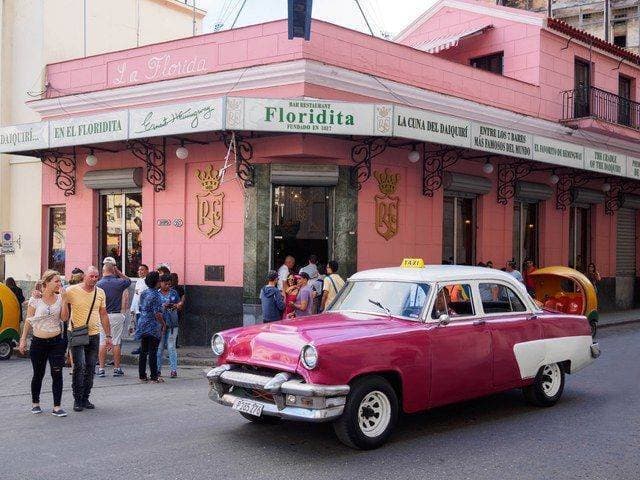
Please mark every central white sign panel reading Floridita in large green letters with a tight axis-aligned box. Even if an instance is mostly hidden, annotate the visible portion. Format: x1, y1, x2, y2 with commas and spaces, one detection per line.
227, 98, 393, 136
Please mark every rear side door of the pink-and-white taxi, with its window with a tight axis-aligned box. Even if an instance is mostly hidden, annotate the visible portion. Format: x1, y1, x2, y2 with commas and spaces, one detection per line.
478, 281, 541, 390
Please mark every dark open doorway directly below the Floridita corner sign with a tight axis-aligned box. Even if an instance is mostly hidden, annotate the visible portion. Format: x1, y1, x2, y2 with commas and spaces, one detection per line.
271, 185, 333, 271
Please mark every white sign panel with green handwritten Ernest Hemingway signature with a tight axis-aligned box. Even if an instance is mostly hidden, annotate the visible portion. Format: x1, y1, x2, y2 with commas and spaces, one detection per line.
129, 98, 223, 138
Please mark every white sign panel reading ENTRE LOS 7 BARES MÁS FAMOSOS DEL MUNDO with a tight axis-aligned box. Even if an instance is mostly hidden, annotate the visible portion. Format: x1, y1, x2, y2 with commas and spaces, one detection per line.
471, 123, 533, 158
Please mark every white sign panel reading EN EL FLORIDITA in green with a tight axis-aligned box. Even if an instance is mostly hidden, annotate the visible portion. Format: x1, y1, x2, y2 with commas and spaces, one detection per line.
49, 110, 129, 147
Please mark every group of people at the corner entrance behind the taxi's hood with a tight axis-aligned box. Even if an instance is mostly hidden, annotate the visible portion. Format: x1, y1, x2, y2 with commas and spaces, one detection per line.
260, 255, 344, 323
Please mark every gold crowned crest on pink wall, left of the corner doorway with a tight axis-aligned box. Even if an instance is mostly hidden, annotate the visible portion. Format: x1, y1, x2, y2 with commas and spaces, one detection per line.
196, 165, 224, 238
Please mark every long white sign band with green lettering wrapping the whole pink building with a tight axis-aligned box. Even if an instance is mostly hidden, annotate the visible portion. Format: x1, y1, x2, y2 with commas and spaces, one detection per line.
0, 97, 640, 179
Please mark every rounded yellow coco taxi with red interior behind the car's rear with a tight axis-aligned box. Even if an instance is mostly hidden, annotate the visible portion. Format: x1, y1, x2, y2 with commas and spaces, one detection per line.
530, 266, 598, 338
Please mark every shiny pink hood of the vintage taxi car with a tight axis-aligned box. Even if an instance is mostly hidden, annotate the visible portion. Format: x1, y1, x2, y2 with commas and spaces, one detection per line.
221, 313, 415, 372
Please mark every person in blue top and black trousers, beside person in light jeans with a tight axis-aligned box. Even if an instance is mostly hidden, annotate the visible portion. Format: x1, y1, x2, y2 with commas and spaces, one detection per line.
136, 272, 166, 383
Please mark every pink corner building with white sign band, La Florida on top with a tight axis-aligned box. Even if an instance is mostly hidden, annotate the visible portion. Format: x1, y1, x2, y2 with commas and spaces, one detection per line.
0, 0, 640, 344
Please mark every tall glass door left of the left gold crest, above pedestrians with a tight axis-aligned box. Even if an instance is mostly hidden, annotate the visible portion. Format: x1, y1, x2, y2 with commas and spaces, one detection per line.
99, 192, 142, 277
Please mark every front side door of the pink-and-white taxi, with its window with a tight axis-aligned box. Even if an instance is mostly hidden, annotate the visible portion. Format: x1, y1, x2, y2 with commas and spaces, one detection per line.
429, 282, 492, 406
